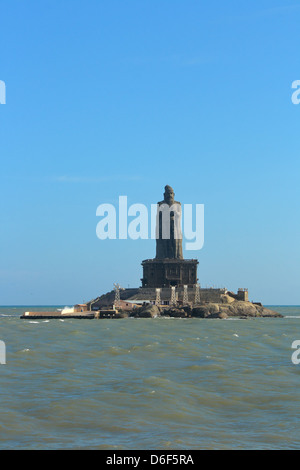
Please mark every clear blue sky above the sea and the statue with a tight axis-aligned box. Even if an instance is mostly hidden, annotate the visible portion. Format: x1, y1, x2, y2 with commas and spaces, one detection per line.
0, 0, 300, 305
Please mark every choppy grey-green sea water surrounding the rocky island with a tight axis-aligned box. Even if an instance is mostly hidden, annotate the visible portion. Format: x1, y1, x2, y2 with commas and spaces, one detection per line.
0, 306, 300, 450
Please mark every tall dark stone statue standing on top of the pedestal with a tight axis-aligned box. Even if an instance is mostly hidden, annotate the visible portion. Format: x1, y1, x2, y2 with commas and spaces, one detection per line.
156, 185, 183, 259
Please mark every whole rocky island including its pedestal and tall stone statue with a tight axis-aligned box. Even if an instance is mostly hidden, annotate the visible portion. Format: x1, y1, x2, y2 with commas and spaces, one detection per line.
21, 186, 282, 319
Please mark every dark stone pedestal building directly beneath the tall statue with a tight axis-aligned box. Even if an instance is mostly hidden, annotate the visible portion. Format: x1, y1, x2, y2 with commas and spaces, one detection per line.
141, 258, 199, 287
